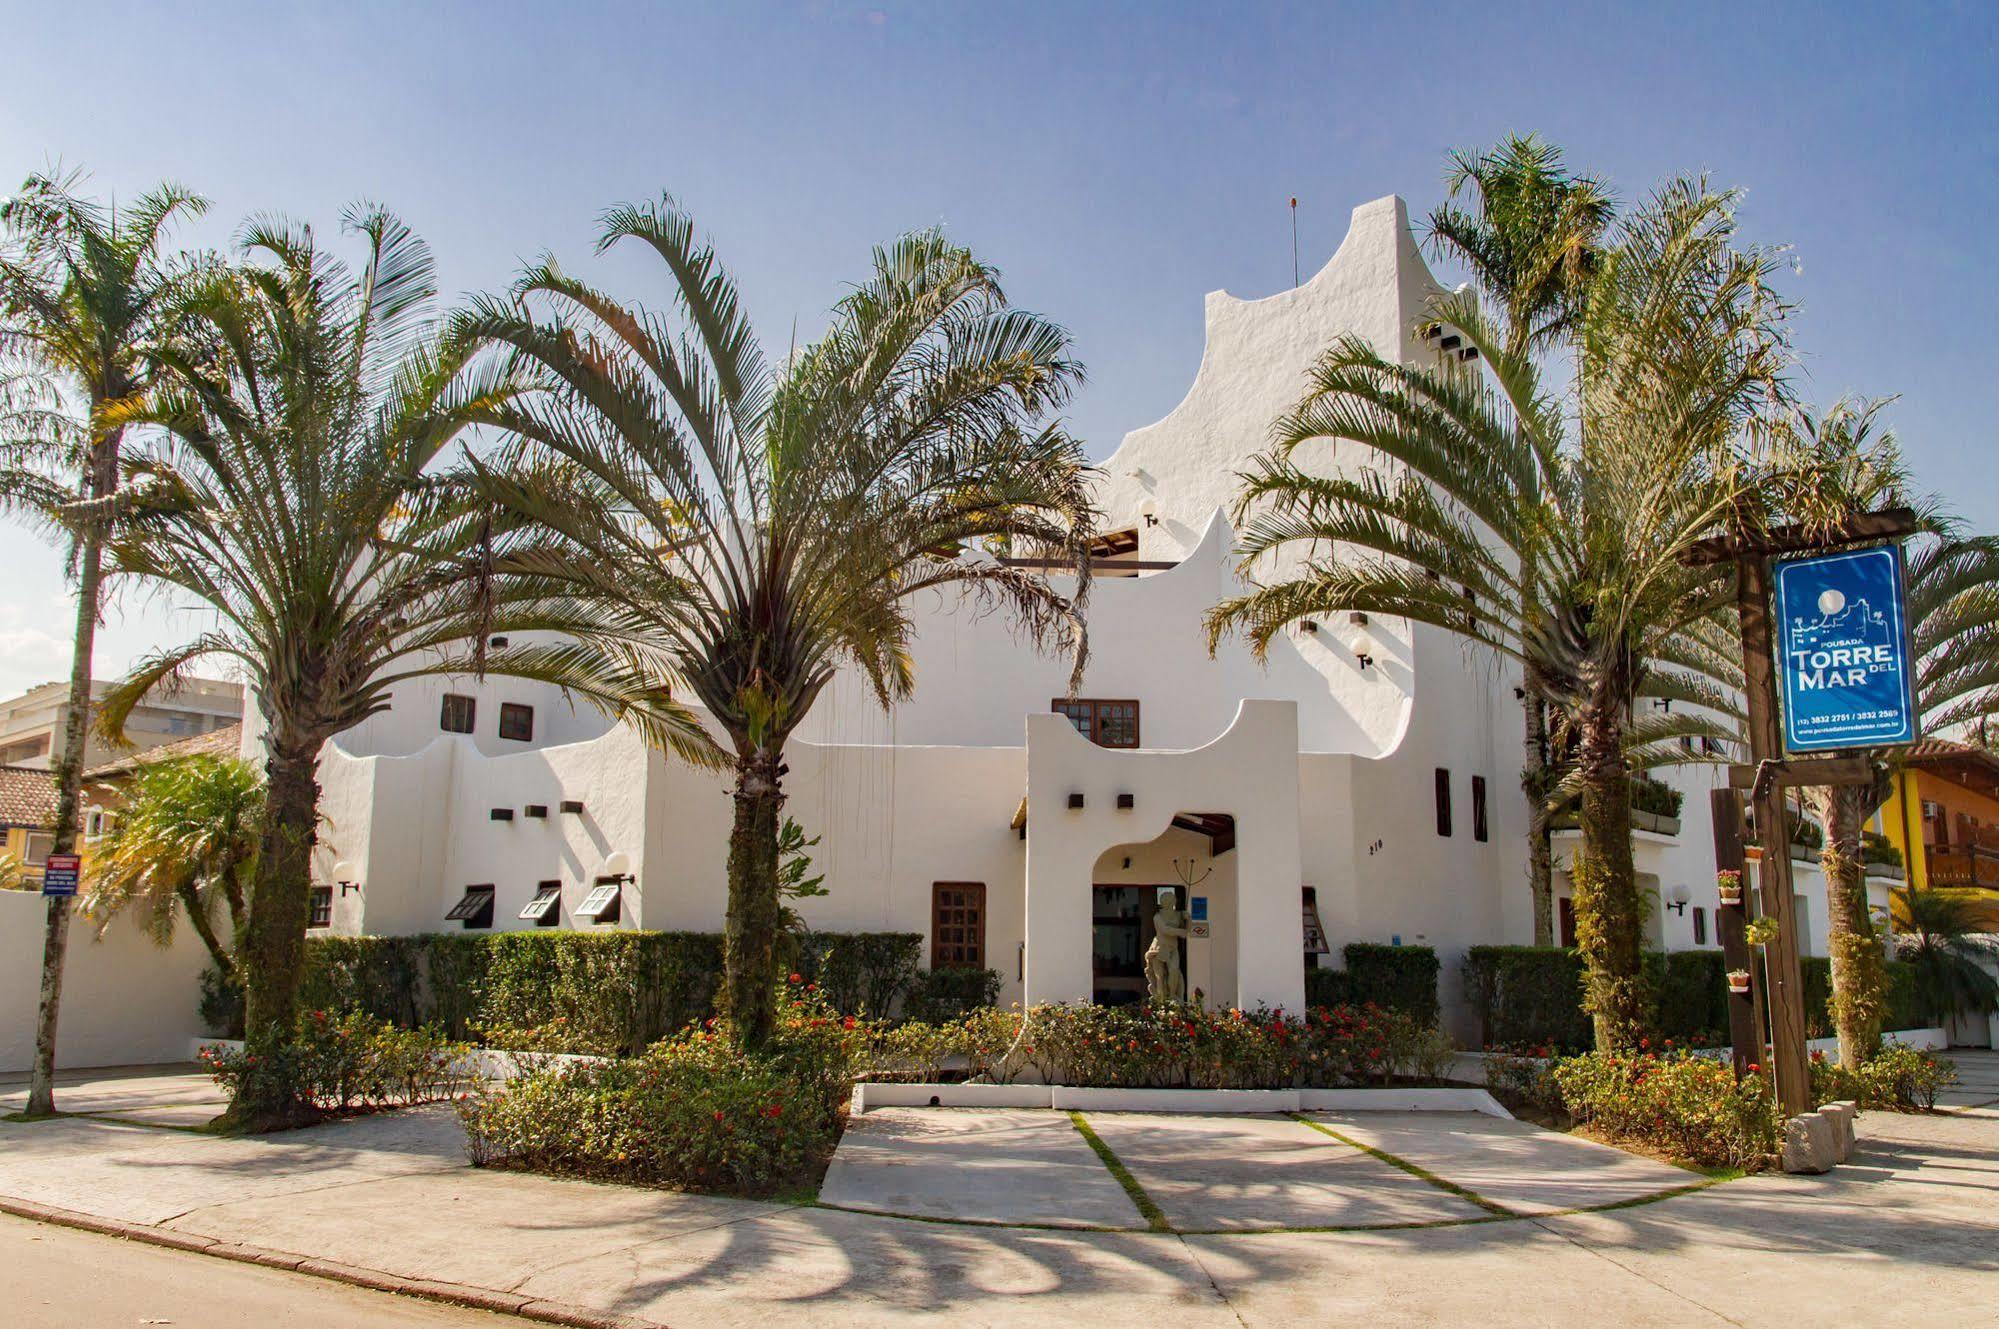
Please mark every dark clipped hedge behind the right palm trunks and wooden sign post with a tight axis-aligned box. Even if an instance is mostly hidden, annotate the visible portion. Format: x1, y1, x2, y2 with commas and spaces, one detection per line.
1463, 945, 1921, 1049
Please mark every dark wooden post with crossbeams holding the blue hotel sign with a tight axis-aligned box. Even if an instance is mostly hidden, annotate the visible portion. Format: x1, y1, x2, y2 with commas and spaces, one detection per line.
1685, 508, 1917, 1117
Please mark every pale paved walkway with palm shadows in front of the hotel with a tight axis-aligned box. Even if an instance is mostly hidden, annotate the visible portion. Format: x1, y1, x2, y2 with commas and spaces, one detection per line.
0, 1053, 1999, 1329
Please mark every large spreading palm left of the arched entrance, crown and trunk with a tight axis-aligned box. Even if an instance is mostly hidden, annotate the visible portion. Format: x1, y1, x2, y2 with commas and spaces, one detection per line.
462, 200, 1095, 1045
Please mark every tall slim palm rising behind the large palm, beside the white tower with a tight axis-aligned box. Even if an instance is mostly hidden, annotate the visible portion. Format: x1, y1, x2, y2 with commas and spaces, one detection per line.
1427, 134, 1615, 945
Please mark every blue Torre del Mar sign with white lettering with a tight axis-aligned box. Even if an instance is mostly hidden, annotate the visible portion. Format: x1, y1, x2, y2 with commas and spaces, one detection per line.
1775, 546, 1917, 751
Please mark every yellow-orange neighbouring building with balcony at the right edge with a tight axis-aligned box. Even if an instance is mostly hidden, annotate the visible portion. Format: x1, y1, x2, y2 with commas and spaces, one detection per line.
1881, 737, 1999, 913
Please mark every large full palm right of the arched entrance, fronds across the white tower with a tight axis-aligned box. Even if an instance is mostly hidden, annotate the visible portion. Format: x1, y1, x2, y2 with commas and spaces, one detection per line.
1209, 180, 1783, 1047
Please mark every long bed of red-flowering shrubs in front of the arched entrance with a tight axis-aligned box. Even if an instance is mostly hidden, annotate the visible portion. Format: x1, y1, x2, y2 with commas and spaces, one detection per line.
851, 1005, 1451, 1089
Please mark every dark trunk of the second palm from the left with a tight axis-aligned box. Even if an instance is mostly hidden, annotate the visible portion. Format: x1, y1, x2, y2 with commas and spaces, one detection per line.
222, 731, 322, 1133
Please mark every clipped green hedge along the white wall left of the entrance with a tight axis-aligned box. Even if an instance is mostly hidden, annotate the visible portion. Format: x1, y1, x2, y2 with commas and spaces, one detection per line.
241, 929, 935, 1055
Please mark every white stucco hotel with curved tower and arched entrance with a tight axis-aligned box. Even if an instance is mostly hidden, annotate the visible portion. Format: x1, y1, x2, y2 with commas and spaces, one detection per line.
277, 198, 1887, 1039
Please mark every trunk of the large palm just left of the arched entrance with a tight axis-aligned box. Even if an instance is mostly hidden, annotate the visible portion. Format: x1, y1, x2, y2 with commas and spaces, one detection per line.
724, 747, 784, 1047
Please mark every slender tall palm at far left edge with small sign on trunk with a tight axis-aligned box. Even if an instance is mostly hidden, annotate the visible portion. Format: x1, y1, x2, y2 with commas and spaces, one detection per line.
0, 174, 208, 1115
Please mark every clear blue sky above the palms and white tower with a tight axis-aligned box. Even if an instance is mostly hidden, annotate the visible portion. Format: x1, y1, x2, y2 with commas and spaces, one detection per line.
0, 0, 1999, 695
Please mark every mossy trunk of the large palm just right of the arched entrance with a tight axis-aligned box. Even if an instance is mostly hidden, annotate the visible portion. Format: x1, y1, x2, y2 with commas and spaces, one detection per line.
1571, 689, 1645, 1051
